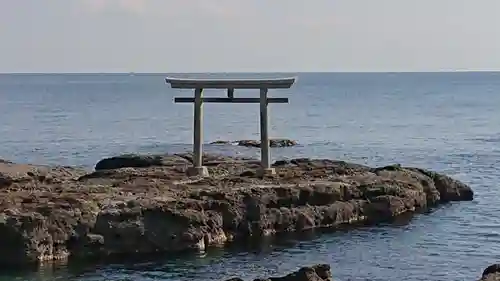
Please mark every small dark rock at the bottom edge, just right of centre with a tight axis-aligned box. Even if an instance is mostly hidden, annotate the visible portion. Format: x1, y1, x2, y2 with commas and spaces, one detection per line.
226, 264, 333, 281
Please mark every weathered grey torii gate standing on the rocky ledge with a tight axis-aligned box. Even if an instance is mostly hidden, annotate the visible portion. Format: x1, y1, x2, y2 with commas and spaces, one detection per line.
165, 77, 296, 176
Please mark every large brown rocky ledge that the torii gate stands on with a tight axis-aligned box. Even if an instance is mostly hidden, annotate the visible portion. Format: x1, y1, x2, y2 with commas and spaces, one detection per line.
0, 154, 472, 266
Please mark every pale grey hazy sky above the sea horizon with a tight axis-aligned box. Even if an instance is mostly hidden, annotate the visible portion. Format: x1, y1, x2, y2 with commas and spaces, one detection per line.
0, 0, 500, 73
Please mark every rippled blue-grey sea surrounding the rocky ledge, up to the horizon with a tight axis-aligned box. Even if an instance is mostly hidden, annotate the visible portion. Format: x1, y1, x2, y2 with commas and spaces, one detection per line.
0, 72, 500, 281
